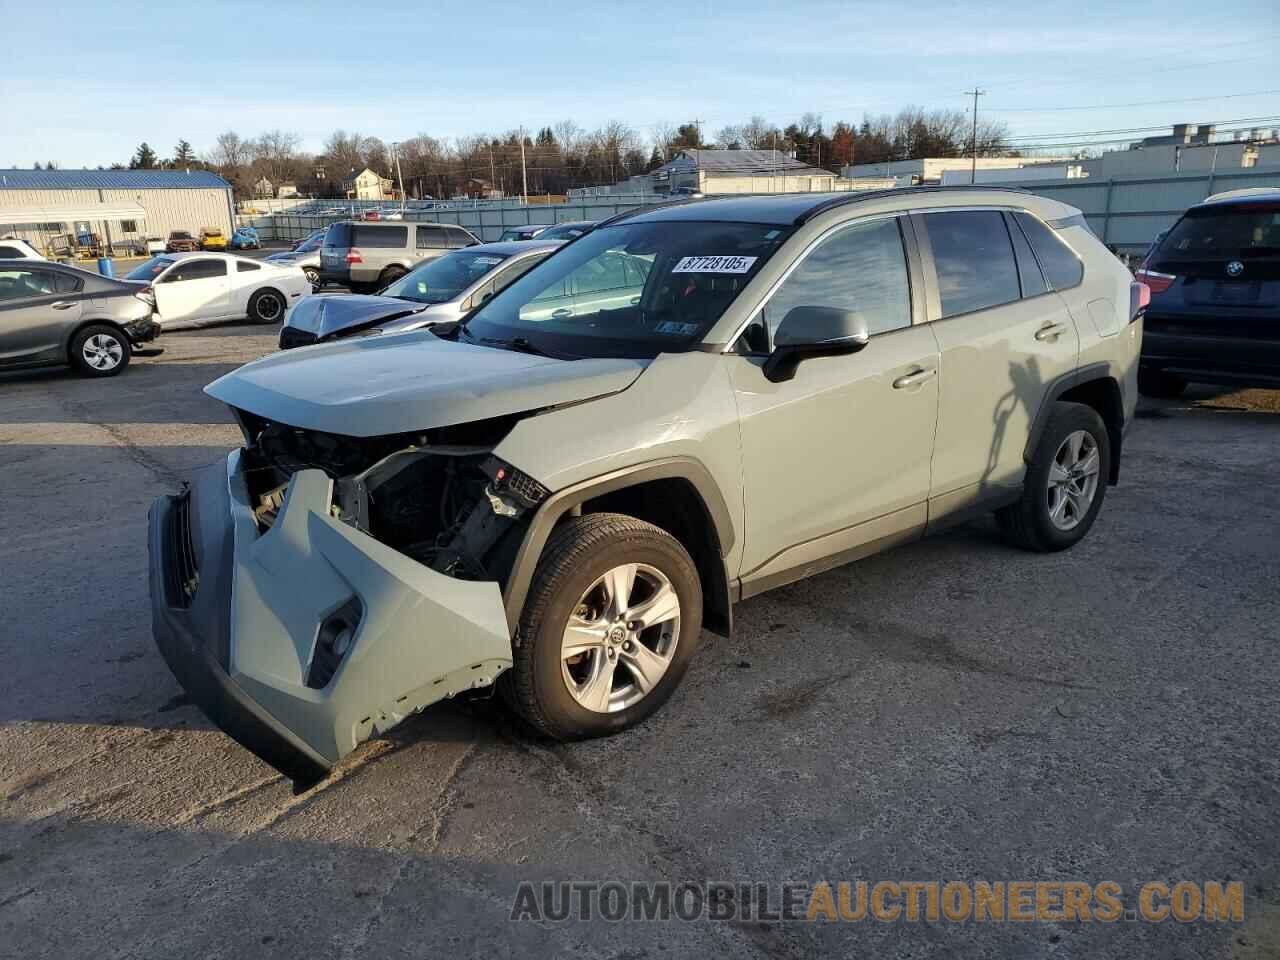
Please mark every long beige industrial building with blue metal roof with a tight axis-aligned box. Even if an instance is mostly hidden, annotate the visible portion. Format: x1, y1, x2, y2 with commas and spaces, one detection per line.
0, 169, 236, 257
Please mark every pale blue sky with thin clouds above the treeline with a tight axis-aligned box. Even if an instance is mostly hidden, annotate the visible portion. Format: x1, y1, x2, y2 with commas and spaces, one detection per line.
0, 0, 1280, 166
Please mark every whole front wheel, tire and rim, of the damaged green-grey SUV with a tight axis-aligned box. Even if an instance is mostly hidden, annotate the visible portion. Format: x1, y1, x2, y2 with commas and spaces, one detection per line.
500, 513, 703, 740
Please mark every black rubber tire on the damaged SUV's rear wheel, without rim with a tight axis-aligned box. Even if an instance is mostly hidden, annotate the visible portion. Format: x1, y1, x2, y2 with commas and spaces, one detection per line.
996, 401, 1111, 553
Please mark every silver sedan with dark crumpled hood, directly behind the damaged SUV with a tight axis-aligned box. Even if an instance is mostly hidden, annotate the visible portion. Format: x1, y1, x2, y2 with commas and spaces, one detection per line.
280, 241, 563, 349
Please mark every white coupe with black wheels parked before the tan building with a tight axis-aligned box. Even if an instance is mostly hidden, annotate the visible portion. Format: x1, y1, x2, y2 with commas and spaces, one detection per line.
124, 253, 311, 325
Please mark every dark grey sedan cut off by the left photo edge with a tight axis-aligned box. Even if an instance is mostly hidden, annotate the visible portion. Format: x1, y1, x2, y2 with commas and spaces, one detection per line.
0, 260, 160, 376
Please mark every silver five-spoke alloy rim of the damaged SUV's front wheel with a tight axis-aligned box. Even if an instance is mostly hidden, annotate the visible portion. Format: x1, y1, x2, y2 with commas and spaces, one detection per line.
561, 563, 680, 713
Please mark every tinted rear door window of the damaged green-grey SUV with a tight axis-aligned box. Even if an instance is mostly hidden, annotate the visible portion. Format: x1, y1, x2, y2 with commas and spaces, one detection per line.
924, 210, 1021, 319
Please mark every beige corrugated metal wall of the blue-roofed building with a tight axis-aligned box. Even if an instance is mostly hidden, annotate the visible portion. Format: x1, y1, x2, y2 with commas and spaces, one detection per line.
0, 188, 234, 246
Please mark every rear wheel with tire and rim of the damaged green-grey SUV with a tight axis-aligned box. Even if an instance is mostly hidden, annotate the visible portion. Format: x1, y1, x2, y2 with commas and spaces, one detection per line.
996, 401, 1111, 553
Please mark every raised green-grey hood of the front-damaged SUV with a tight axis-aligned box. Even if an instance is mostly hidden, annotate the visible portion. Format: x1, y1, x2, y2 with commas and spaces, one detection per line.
212, 330, 645, 436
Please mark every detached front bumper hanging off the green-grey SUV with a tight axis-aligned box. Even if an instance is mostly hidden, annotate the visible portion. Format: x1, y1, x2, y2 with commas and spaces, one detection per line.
148, 452, 511, 788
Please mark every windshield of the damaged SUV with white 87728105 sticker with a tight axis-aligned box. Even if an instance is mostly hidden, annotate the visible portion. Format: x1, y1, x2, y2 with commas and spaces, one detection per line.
463, 220, 788, 358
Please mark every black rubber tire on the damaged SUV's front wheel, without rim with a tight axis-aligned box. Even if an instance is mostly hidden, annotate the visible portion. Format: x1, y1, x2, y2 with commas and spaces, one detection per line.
499, 513, 703, 740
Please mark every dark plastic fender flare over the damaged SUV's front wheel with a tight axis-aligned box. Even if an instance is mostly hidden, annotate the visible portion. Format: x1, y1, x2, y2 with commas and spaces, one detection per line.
502, 457, 735, 634
